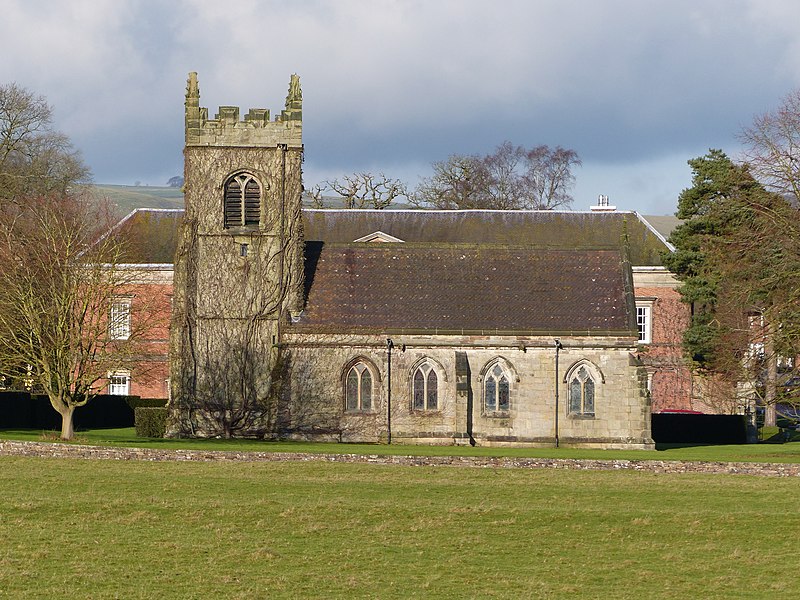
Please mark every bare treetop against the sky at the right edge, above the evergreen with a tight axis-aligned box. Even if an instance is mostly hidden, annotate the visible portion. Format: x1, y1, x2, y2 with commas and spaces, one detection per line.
739, 90, 800, 202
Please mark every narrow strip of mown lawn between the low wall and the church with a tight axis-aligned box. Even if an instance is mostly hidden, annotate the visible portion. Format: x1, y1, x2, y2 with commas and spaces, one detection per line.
0, 428, 800, 463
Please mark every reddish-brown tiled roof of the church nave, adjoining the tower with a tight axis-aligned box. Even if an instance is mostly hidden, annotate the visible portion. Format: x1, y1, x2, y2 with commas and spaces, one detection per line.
291, 242, 632, 336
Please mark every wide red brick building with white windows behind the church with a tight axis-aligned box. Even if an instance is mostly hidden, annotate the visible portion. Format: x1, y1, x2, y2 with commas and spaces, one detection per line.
114, 204, 692, 412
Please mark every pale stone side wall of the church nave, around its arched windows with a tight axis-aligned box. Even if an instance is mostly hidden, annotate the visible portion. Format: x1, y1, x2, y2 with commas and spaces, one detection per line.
279, 332, 652, 448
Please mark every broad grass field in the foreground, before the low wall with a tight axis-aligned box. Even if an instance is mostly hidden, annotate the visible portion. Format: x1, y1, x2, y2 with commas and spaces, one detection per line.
0, 457, 800, 599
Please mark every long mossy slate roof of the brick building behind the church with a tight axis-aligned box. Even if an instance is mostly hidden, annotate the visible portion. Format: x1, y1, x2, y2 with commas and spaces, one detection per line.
115, 209, 670, 266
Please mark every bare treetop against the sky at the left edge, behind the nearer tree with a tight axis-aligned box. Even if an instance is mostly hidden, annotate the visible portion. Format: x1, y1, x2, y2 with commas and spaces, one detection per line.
0, 83, 89, 200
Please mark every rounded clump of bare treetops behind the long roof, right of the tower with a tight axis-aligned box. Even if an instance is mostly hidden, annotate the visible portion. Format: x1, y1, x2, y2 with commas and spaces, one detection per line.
412, 142, 581, 210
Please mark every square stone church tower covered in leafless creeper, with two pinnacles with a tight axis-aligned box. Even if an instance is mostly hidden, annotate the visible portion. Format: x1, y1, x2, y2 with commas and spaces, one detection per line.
170, 73, 303, 436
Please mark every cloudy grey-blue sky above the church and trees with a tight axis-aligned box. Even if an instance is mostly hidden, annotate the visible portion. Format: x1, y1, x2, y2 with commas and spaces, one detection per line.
0, 0, 800, 215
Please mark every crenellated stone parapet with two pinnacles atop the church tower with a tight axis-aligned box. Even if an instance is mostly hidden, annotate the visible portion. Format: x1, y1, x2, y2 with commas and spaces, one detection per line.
186, 72, 303, 148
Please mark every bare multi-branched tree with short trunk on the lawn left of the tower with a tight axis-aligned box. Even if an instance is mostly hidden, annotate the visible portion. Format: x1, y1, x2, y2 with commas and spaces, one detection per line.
0, 195, 162, 440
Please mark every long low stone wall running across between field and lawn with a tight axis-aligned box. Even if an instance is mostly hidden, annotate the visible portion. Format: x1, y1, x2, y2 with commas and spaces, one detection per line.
0, 441, 800, 477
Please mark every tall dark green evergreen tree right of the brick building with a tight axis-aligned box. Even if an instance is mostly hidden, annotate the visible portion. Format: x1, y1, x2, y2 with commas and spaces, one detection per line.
664, 150, 800, 420
